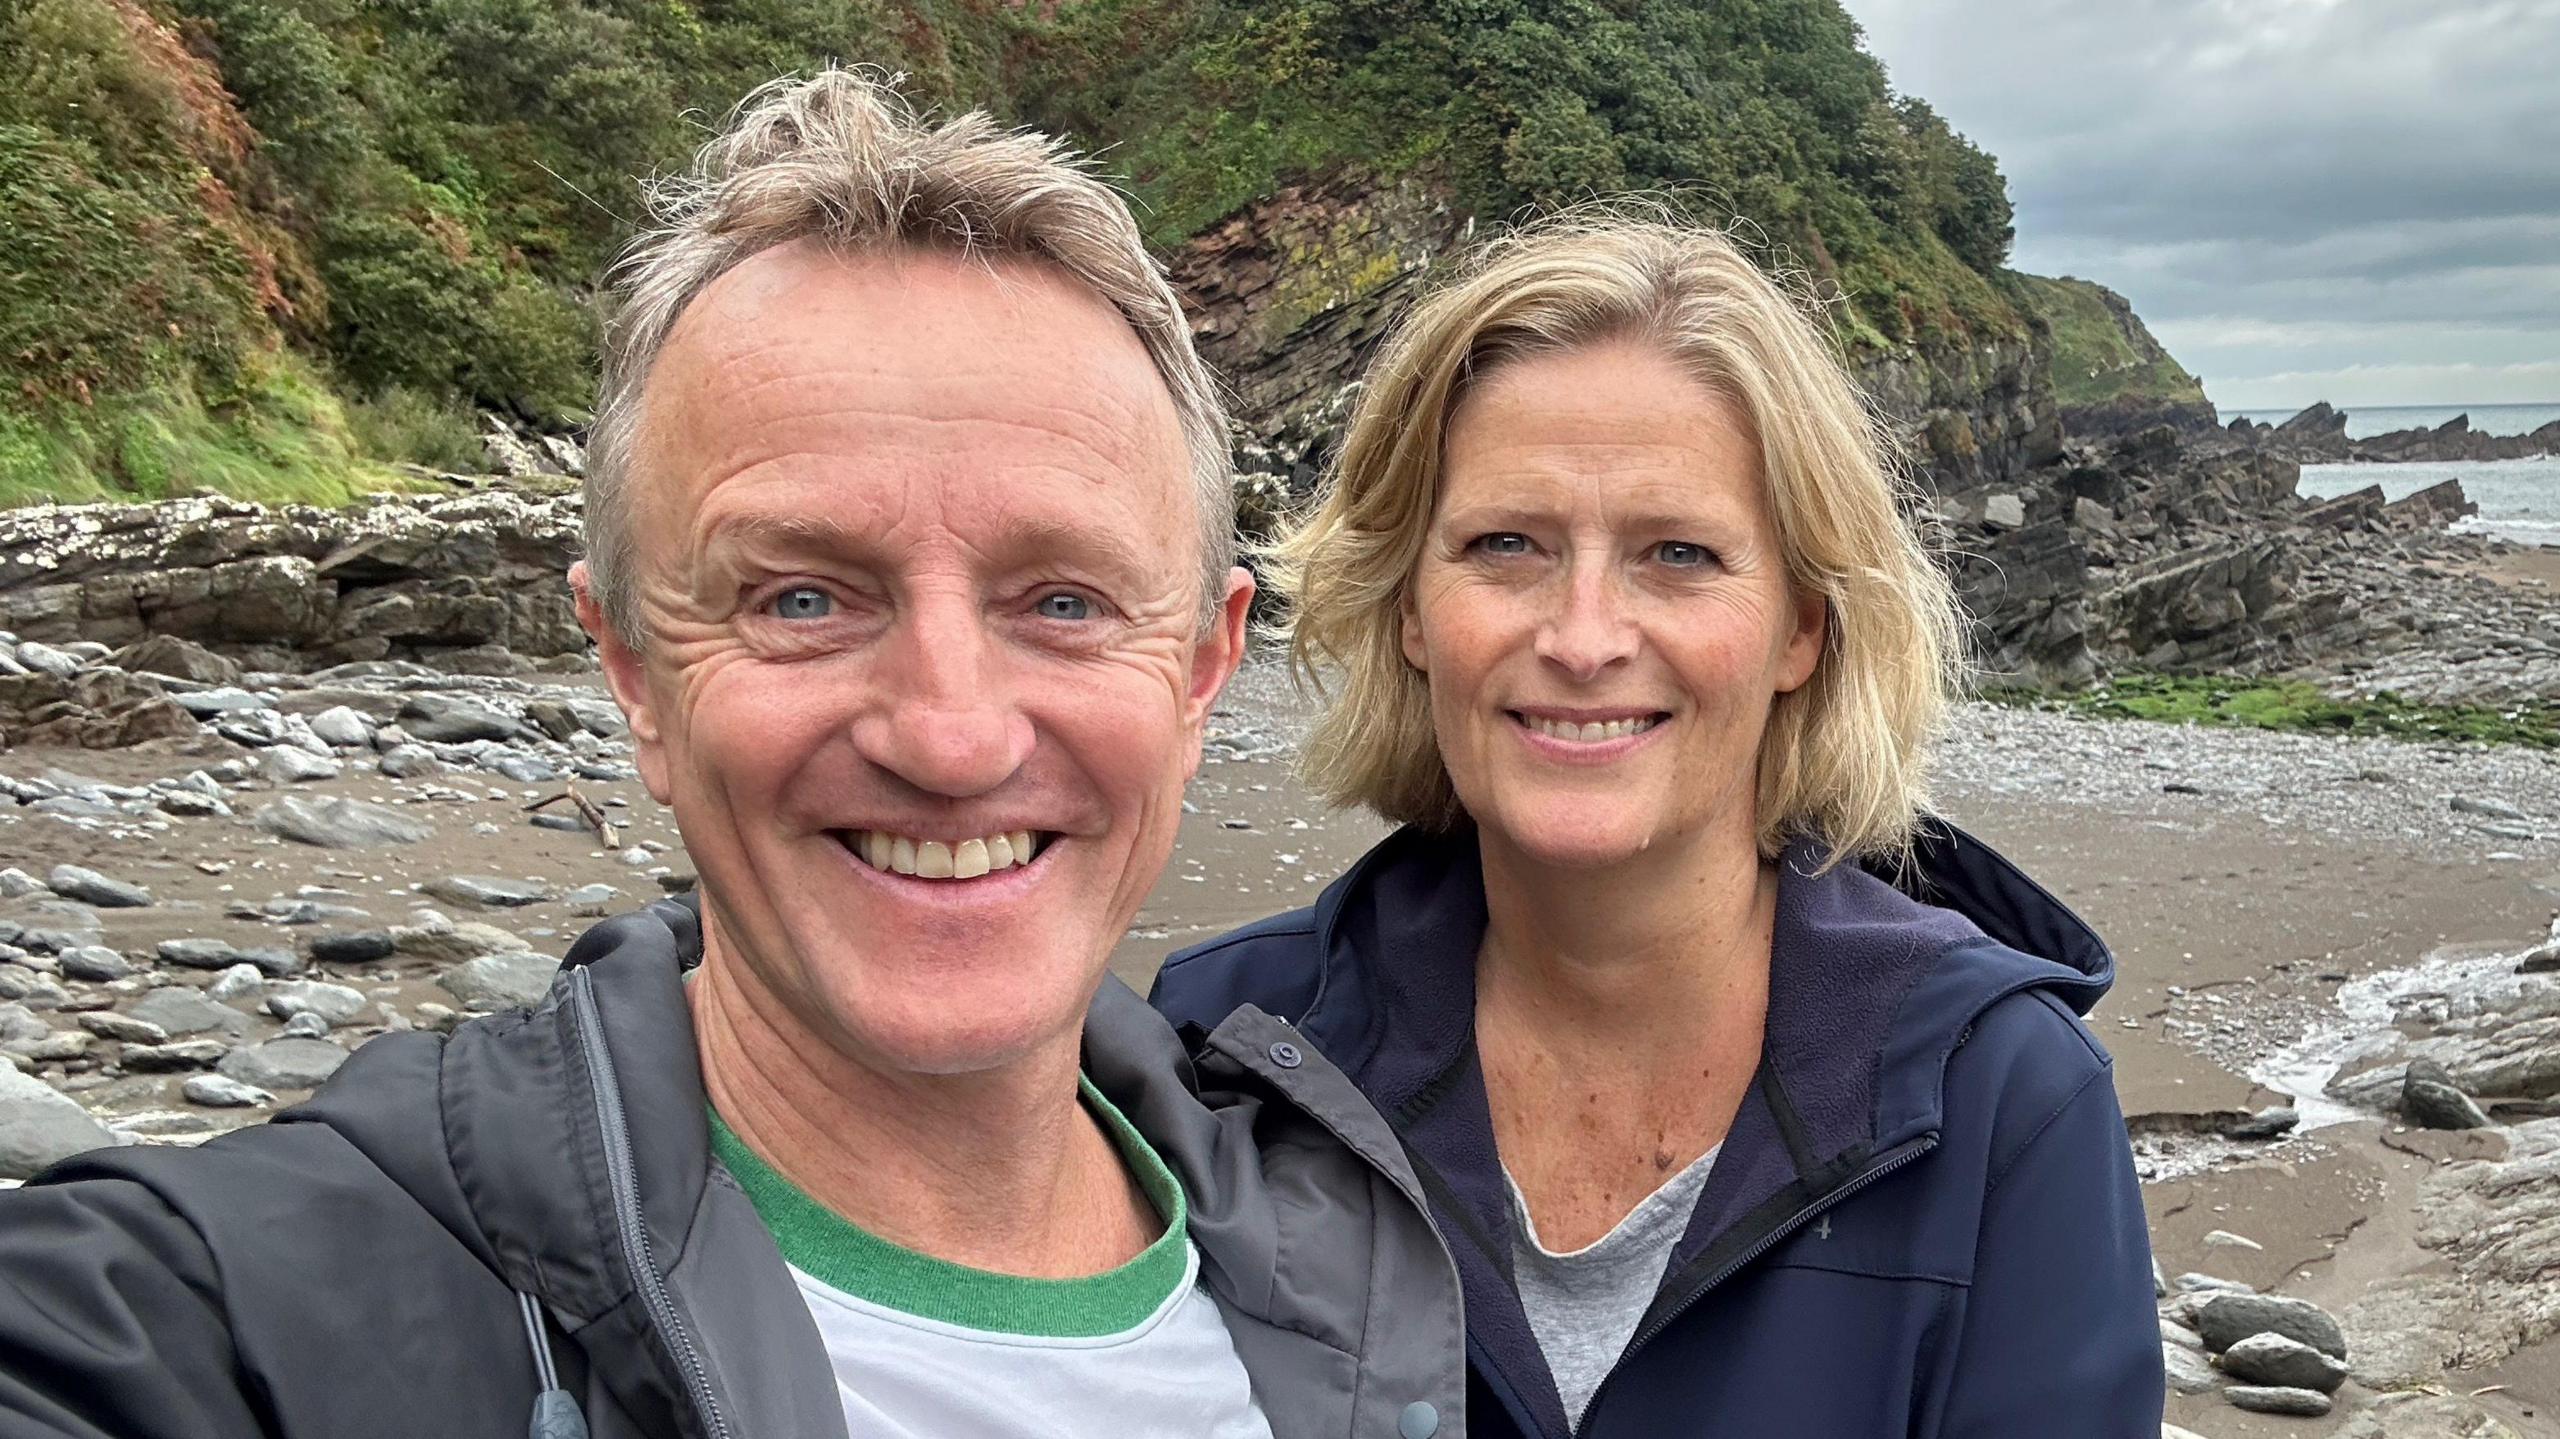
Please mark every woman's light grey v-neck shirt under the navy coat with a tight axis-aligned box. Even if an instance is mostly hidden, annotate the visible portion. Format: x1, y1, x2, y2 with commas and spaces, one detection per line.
1503, 1145, 1723, 1429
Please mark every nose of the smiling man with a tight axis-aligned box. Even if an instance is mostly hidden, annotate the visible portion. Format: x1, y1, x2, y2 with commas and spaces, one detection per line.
852, 602, 1034, 799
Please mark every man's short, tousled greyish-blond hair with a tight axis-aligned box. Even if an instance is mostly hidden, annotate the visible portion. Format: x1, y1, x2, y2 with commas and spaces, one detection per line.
586, 69, 1236, 648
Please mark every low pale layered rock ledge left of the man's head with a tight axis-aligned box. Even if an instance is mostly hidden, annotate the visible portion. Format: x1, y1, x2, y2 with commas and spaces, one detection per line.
0, 489, 586, 673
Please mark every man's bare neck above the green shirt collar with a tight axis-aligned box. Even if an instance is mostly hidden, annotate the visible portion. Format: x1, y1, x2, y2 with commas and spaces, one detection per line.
689, 935, 1162, 1278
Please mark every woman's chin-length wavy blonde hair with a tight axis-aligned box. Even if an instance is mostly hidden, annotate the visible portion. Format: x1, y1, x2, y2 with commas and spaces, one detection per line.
1262, 205, 1961, 865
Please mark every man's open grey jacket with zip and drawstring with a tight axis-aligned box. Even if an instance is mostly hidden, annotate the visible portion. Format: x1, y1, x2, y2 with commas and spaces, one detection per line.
0, 901, 1464, 1439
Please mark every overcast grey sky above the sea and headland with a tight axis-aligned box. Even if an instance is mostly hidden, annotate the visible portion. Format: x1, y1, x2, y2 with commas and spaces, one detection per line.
1843, 0, 2560, 407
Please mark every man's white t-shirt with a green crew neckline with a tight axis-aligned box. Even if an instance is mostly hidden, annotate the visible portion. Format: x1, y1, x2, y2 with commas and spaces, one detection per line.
712, 1083, 1270, 1439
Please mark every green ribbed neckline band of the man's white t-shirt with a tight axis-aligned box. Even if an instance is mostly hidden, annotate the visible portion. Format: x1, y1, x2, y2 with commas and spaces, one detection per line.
704, 1075, 1190, 1339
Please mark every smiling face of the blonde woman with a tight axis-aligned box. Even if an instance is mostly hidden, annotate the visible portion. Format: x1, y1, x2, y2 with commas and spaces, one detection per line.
1403, 341, 1823, 865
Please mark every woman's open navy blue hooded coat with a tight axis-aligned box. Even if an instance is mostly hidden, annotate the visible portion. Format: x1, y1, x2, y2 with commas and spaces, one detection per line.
1152, 827, 2163, 1439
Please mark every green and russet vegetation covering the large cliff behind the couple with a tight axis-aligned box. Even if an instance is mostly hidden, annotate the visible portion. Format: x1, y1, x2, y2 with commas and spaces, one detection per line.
0, 0, 2025, 499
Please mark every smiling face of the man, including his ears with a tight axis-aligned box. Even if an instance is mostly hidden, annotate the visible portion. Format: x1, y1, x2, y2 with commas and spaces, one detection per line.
581, 246, 1252, 1073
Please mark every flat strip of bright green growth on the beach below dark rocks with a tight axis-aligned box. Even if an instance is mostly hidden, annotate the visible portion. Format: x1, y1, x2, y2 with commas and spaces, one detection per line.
1984, 673, 2560, 750
